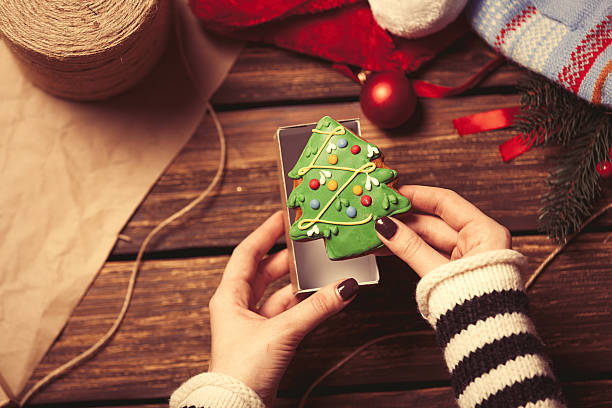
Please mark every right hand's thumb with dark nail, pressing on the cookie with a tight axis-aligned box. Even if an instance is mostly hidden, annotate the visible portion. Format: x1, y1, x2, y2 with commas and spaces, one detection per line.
375, 217, 448, 277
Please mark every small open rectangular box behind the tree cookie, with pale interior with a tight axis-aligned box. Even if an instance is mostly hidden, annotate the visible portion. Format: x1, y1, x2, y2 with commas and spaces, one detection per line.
276, 119, 380, 294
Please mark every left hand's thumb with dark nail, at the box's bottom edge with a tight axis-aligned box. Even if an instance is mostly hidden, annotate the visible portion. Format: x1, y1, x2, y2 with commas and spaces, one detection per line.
276, 278, 359, 339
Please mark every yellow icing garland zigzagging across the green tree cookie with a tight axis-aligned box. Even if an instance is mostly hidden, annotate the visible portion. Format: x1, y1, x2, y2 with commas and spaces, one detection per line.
297, 125, 376, 230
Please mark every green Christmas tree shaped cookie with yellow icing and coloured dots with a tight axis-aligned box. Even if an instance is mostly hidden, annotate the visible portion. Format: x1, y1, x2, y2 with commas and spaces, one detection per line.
287, 116, 411, 259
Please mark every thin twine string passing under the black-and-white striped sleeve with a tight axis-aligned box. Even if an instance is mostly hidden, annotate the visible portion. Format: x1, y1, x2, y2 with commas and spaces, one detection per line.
298, 202, 612, 408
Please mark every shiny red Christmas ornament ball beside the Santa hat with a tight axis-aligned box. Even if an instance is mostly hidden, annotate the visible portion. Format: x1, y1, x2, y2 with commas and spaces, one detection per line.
359, 71, 416, 129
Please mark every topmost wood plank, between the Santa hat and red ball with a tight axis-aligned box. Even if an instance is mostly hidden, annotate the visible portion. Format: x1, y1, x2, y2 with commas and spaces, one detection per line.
212, 34, 526, 105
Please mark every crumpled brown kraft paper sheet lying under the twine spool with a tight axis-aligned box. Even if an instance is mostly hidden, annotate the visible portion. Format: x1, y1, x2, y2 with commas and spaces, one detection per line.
0, 2, 241, 405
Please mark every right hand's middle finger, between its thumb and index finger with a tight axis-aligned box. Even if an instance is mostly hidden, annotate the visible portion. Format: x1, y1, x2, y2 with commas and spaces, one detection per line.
402, 214, 459, 254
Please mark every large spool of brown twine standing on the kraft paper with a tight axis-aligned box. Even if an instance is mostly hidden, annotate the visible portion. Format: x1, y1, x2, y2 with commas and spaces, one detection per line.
0, 0, 172, 100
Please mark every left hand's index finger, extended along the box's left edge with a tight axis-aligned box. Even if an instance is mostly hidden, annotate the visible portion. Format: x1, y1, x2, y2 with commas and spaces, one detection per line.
220, 211, 285, 288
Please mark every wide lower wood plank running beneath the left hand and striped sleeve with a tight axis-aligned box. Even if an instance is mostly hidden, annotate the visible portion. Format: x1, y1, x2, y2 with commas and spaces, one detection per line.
29, 233, 612, 403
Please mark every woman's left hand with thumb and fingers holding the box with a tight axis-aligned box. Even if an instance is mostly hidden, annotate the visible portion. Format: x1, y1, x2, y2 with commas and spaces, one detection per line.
209, 211, 358, 405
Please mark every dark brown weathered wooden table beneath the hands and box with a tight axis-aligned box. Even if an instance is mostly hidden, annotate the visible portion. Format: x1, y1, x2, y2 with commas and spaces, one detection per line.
23, 37, 612, 408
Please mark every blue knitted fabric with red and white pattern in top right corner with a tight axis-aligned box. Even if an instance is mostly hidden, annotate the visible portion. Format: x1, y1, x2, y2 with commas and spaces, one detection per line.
466, 0, 612, 107
